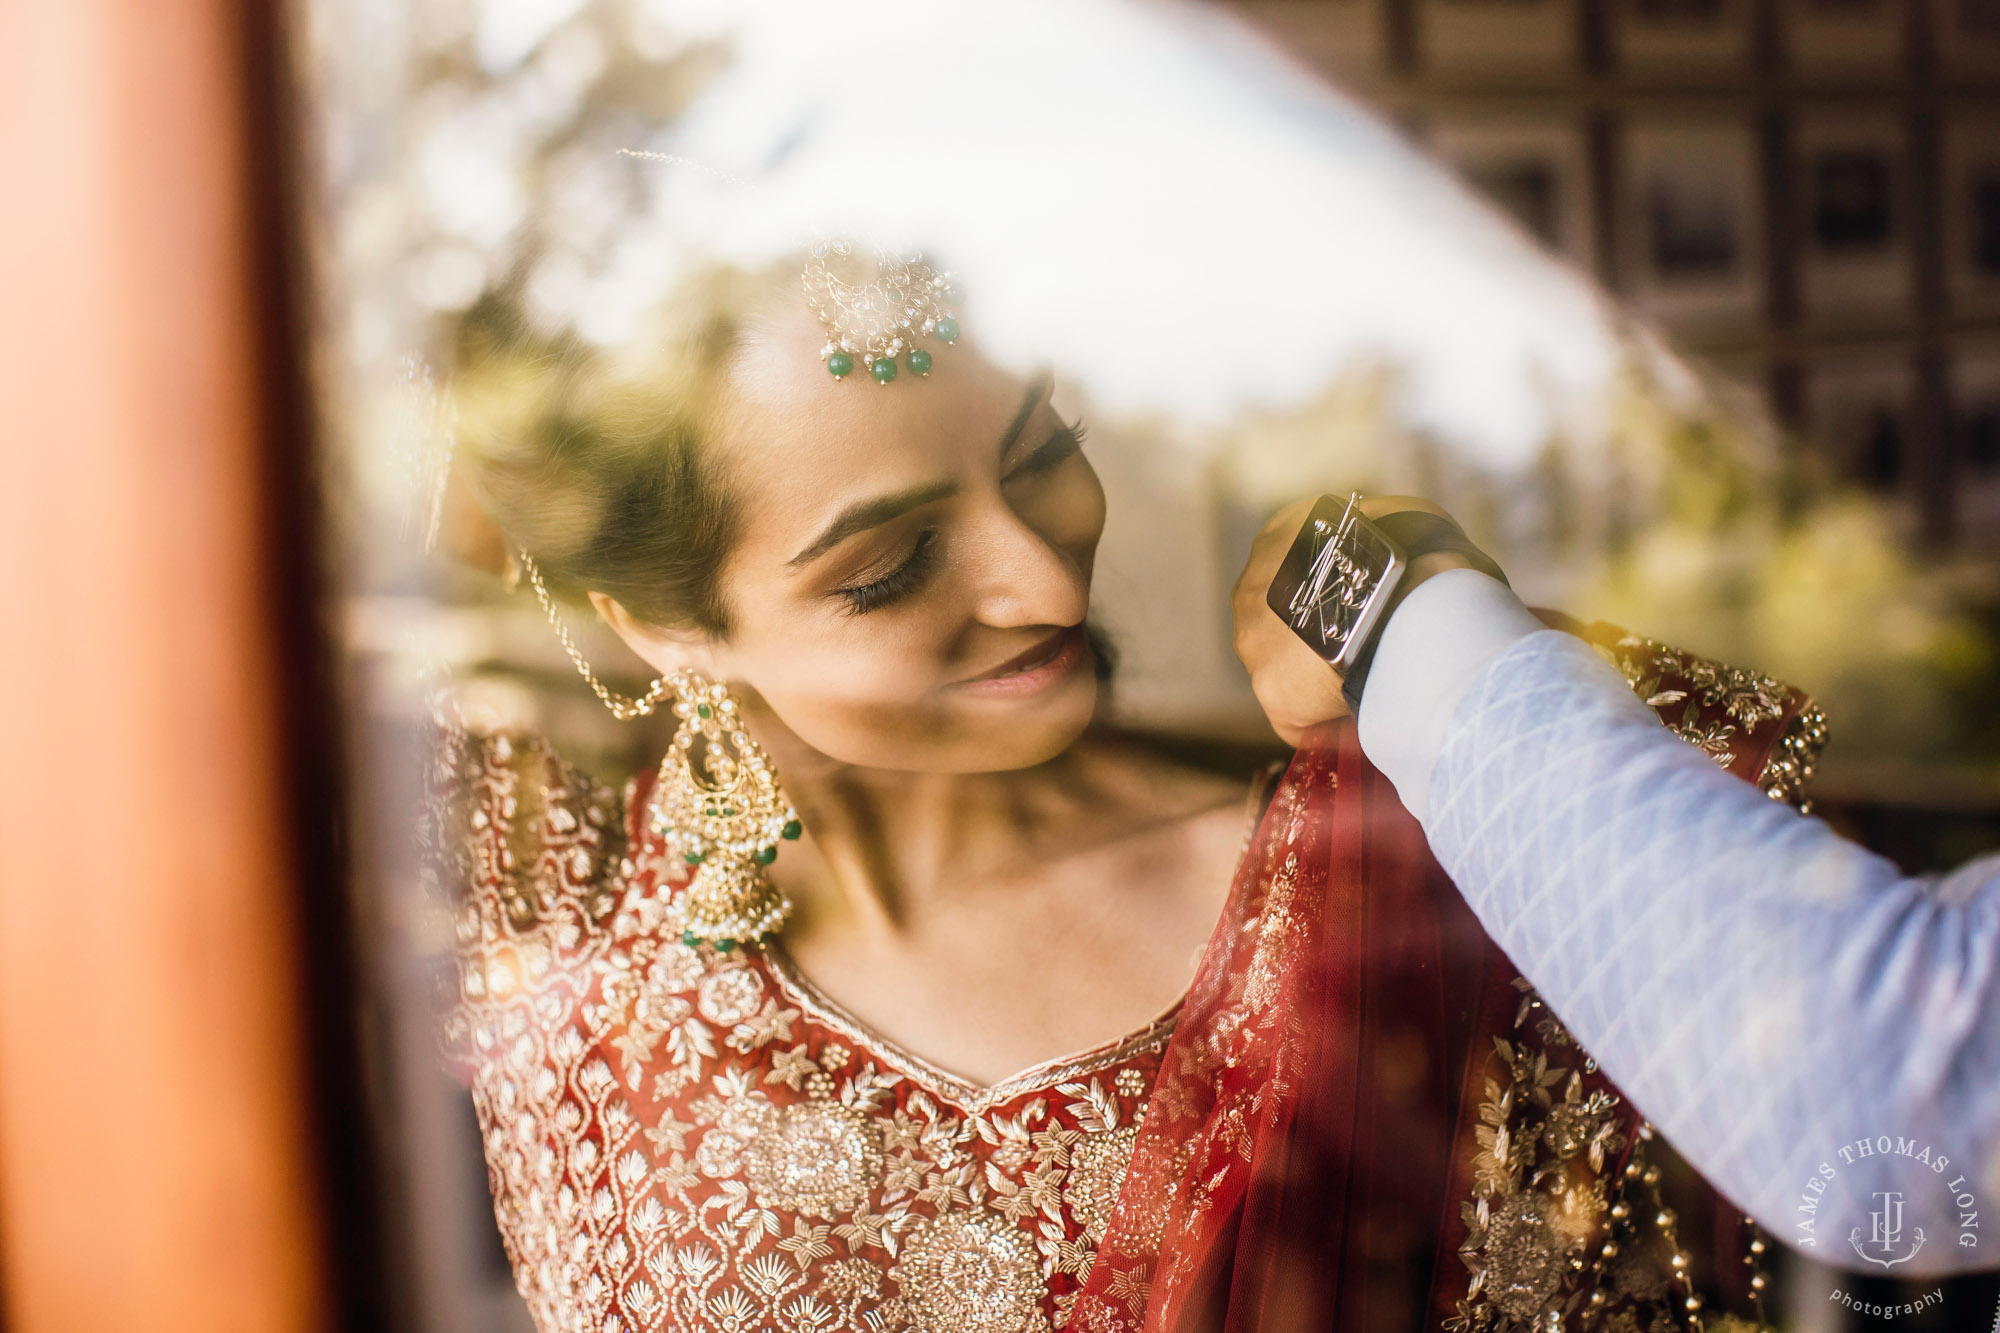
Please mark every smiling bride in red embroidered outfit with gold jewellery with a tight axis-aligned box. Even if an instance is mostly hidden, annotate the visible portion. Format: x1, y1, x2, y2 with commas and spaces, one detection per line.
434, 250, 1814, 1333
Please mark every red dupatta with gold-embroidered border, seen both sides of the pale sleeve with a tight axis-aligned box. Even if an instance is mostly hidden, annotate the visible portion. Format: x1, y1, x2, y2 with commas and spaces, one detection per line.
1066, 626, 1824, 1333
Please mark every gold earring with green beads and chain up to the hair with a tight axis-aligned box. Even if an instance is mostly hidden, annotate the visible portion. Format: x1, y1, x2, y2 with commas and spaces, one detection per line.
518, 550, 802, 953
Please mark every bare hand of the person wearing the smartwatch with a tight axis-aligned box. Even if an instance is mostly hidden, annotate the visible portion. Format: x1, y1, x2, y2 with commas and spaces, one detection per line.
1230, 494, 1472, 747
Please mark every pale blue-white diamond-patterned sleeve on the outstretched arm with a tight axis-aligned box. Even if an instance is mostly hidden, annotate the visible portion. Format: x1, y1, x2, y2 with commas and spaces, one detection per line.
1360, 574, 2000, 1277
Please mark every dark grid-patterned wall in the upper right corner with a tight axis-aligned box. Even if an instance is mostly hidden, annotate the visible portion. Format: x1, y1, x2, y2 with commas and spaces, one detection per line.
1234, 0, 2000, 552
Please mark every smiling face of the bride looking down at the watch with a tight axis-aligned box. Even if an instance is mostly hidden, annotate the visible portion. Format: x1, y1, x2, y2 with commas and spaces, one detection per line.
612, 300, 1104, 773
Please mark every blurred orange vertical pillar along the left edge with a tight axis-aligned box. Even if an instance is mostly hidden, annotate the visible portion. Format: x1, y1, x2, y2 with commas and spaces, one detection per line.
0, 0, 324, 1333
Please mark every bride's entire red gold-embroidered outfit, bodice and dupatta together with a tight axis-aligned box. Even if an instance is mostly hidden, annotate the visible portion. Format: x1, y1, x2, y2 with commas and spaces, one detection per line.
434, 626, 1824, 1333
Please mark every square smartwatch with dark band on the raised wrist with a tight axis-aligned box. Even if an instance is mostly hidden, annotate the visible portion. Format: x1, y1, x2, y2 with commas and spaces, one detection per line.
1264, 490, 1506, 713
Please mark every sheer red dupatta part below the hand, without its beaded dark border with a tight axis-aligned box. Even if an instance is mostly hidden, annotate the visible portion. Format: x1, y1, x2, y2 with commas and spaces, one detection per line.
1068, 725, 1462, 1333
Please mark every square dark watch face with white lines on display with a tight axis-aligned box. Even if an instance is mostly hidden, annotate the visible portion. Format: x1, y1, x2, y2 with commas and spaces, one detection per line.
1266, 494, 1404, 675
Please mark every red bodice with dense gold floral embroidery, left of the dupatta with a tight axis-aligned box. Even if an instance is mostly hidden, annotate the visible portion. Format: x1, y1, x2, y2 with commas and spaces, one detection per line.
430, 733, 1172, 1333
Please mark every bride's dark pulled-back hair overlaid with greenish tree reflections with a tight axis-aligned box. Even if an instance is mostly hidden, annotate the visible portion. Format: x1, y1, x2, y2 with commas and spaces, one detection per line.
454, 272, 792, 636
